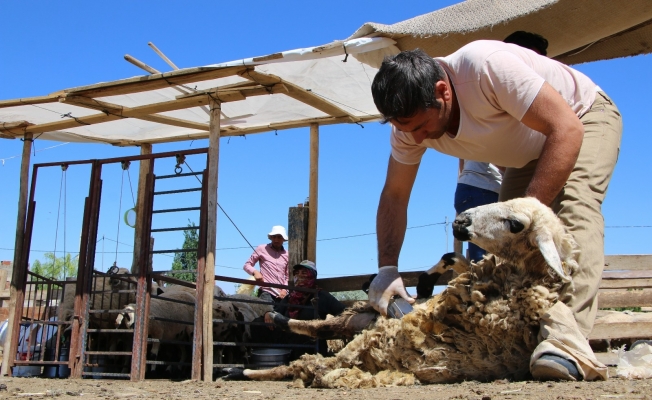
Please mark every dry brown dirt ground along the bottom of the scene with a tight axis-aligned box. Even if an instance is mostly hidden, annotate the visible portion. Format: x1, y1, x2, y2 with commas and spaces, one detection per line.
0, 371, 652, 400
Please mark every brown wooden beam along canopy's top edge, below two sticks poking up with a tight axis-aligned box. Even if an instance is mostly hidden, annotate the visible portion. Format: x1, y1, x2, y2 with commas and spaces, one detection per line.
65, 67, 248, 97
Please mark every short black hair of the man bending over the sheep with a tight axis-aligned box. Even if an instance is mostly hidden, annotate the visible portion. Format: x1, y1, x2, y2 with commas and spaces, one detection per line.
371, 49, 446, 123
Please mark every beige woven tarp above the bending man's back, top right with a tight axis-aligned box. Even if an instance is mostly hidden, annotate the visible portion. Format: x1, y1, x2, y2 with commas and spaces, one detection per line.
351, 0, 652, 65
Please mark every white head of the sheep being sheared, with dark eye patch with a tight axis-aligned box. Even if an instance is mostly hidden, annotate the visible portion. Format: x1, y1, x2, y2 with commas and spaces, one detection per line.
453, 197, 578, 282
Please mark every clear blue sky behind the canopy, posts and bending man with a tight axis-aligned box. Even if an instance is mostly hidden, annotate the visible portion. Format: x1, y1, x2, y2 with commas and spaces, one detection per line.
0, 0, 652, 291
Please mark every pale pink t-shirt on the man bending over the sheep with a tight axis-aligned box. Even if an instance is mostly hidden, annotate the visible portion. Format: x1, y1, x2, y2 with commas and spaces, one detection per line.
390, 40, 598, 168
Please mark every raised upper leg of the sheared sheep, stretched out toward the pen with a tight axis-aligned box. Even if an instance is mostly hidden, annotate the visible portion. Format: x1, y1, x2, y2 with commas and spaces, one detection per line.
272, 312, 378, 339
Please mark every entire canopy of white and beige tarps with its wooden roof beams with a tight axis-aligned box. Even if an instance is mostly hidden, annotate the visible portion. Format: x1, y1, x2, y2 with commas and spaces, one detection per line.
0, 0, 652, 146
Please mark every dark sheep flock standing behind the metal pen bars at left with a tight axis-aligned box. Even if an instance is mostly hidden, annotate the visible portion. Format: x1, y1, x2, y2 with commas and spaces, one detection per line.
60, 268, 272, 378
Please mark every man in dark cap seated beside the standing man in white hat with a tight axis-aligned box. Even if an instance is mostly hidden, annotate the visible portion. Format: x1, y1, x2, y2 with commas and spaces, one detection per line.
251, 260, 345, 360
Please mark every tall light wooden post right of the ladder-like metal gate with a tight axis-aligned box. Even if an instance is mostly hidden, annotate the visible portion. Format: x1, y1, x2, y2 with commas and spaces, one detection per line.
201, 97, 222, 382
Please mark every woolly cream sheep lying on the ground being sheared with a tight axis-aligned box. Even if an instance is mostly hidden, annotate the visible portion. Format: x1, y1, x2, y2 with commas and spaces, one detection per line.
227, 198, 579, 388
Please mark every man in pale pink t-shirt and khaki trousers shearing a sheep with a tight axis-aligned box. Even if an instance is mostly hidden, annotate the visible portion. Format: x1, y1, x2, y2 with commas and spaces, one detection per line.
369, 40, 622, 380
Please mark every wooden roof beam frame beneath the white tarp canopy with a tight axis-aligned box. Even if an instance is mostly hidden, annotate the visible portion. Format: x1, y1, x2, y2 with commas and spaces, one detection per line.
0, 66, 380, 146
